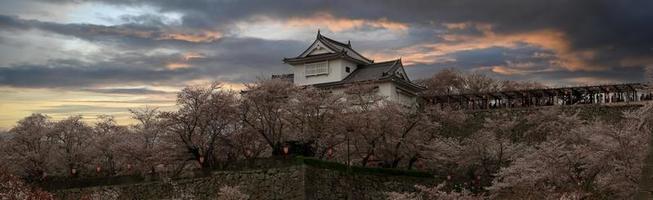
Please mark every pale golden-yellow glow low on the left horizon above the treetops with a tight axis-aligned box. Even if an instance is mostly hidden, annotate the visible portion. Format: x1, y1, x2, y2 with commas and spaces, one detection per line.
0, 87, 176, 129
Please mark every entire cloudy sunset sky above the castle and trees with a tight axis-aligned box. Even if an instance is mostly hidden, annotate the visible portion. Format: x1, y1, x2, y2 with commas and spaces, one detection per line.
0, 0, 653, 129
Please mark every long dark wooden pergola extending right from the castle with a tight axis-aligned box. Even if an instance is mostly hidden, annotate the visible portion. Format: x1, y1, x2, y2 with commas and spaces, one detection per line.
421, 83, 653, 110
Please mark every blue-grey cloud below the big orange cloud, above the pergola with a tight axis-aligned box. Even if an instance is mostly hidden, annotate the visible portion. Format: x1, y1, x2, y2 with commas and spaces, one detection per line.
406, 45, 645, 86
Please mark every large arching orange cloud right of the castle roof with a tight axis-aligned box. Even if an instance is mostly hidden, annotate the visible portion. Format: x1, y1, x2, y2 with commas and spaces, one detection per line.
372, 23, 600, 71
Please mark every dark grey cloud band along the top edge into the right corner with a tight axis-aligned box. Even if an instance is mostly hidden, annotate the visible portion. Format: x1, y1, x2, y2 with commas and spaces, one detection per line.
52, 0, 653, 70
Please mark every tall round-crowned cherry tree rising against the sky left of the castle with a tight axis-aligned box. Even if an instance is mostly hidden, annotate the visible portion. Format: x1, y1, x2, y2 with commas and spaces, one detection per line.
161, 83, 238, 168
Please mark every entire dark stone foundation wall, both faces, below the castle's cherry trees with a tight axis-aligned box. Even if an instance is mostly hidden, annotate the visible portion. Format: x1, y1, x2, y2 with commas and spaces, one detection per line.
53, 165, 435, 200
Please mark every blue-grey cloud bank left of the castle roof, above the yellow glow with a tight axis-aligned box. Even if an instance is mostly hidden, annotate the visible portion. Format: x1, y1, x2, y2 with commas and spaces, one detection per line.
0, 34, 304, 88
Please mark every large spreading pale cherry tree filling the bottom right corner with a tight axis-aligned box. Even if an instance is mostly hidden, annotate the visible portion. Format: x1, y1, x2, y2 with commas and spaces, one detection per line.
488, 105, 653, 199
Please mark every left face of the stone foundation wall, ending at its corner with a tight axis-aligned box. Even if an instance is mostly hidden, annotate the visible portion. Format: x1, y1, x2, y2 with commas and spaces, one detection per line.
54, 166, 305, 200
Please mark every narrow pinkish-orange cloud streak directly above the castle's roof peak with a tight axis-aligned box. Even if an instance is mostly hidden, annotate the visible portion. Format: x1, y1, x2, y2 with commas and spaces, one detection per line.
286, 12, 408, 32
